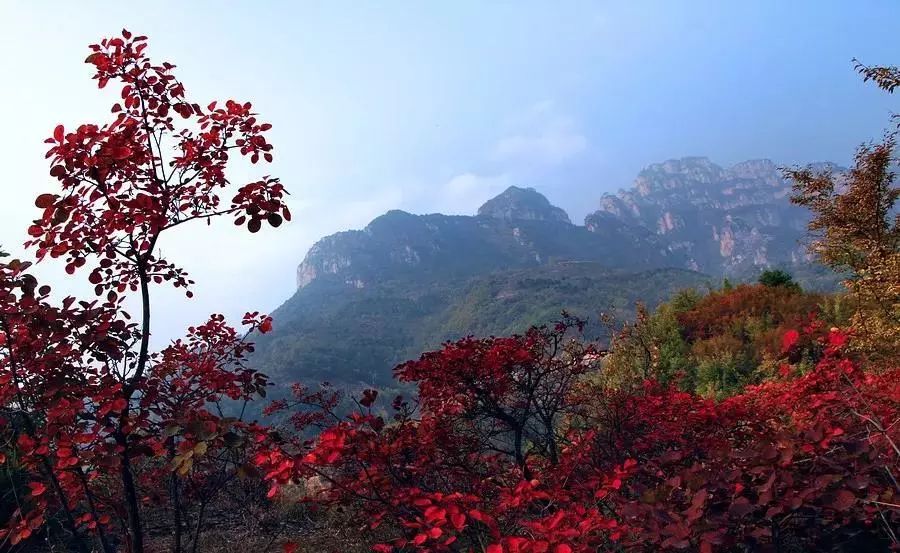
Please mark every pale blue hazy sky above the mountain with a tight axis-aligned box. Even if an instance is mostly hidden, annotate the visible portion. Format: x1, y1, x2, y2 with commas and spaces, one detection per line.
0, 0, 900, 344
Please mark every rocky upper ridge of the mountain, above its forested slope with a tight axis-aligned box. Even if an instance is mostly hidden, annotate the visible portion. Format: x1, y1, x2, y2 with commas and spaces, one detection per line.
297, 156, 840, 294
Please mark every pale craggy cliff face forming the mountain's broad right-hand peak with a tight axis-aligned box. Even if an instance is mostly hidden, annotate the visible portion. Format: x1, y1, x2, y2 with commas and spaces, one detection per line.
585, 158, 828, 277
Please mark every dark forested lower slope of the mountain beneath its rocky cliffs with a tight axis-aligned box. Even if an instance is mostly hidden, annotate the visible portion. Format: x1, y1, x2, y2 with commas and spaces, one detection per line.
257, 262, 709, 387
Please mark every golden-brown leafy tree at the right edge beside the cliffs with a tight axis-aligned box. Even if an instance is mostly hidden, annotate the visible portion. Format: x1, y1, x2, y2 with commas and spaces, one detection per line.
786, 63, 900, 365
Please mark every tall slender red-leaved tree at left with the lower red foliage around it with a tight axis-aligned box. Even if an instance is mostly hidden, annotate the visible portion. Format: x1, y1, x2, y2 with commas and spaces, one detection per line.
0, 31, 290, 553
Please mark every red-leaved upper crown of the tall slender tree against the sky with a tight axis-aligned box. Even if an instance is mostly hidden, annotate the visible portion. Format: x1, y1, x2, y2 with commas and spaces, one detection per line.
27, 32, 290, 301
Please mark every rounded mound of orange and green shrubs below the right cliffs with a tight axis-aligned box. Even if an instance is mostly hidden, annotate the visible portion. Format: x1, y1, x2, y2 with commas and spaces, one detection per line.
602, 284, 849, 399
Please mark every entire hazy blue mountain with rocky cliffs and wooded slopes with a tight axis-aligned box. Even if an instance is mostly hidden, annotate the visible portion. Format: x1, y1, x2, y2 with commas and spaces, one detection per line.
256, 158, 835, 386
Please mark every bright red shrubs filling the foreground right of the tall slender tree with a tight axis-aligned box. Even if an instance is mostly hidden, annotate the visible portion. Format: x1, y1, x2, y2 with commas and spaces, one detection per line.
256, 325, 900, 552
